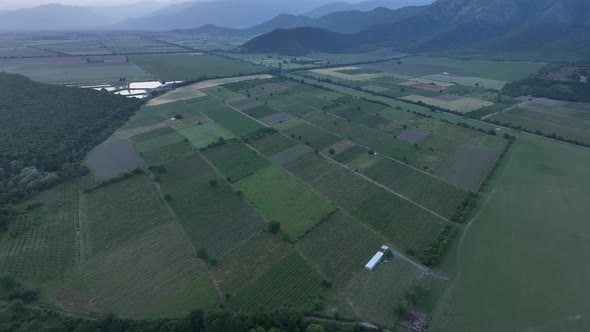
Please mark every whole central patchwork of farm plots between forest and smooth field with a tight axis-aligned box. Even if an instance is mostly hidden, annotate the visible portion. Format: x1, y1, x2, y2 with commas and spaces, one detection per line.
0, 65, 509, 326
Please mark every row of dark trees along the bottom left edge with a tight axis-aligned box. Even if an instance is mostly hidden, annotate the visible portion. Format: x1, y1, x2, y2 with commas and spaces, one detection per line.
0, 300, 361, 332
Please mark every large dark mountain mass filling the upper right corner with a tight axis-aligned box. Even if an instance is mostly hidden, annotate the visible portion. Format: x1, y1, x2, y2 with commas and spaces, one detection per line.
245, 0, 590, 57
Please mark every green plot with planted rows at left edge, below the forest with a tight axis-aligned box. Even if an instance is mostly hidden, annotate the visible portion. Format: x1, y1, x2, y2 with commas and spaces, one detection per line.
0, 178, 88, 282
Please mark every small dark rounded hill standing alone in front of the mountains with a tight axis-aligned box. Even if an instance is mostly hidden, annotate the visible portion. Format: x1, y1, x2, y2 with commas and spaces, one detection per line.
238, 28, 360, 55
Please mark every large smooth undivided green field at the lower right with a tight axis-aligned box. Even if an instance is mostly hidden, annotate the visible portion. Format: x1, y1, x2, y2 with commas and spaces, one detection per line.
431, 135, 590, 331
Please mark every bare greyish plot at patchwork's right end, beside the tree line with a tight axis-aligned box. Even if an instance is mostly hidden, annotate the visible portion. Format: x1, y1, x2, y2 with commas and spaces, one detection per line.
434, 144, 500, 192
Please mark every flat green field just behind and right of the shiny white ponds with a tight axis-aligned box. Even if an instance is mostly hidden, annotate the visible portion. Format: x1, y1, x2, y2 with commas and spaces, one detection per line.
130, 54, 265, 81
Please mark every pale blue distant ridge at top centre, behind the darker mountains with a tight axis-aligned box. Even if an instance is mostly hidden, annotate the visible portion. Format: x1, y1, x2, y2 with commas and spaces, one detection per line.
303, 0, 434, 18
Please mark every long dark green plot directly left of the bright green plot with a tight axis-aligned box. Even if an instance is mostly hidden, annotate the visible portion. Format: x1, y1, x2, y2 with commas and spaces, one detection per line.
160, 155, 266, 258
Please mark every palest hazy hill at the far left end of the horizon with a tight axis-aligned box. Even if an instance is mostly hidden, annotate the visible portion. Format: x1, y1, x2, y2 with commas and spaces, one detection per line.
0, 4, 113, 30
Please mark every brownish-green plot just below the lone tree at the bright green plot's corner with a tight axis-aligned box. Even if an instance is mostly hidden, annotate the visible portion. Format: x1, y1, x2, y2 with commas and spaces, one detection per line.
210, 232, 293, 296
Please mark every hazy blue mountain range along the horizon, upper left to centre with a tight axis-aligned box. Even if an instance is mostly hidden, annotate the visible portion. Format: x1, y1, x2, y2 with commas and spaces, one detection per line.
0, 0, 433, 31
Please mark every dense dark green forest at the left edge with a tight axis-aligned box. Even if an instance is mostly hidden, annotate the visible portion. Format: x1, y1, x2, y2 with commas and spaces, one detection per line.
0, 73, 141, 231
